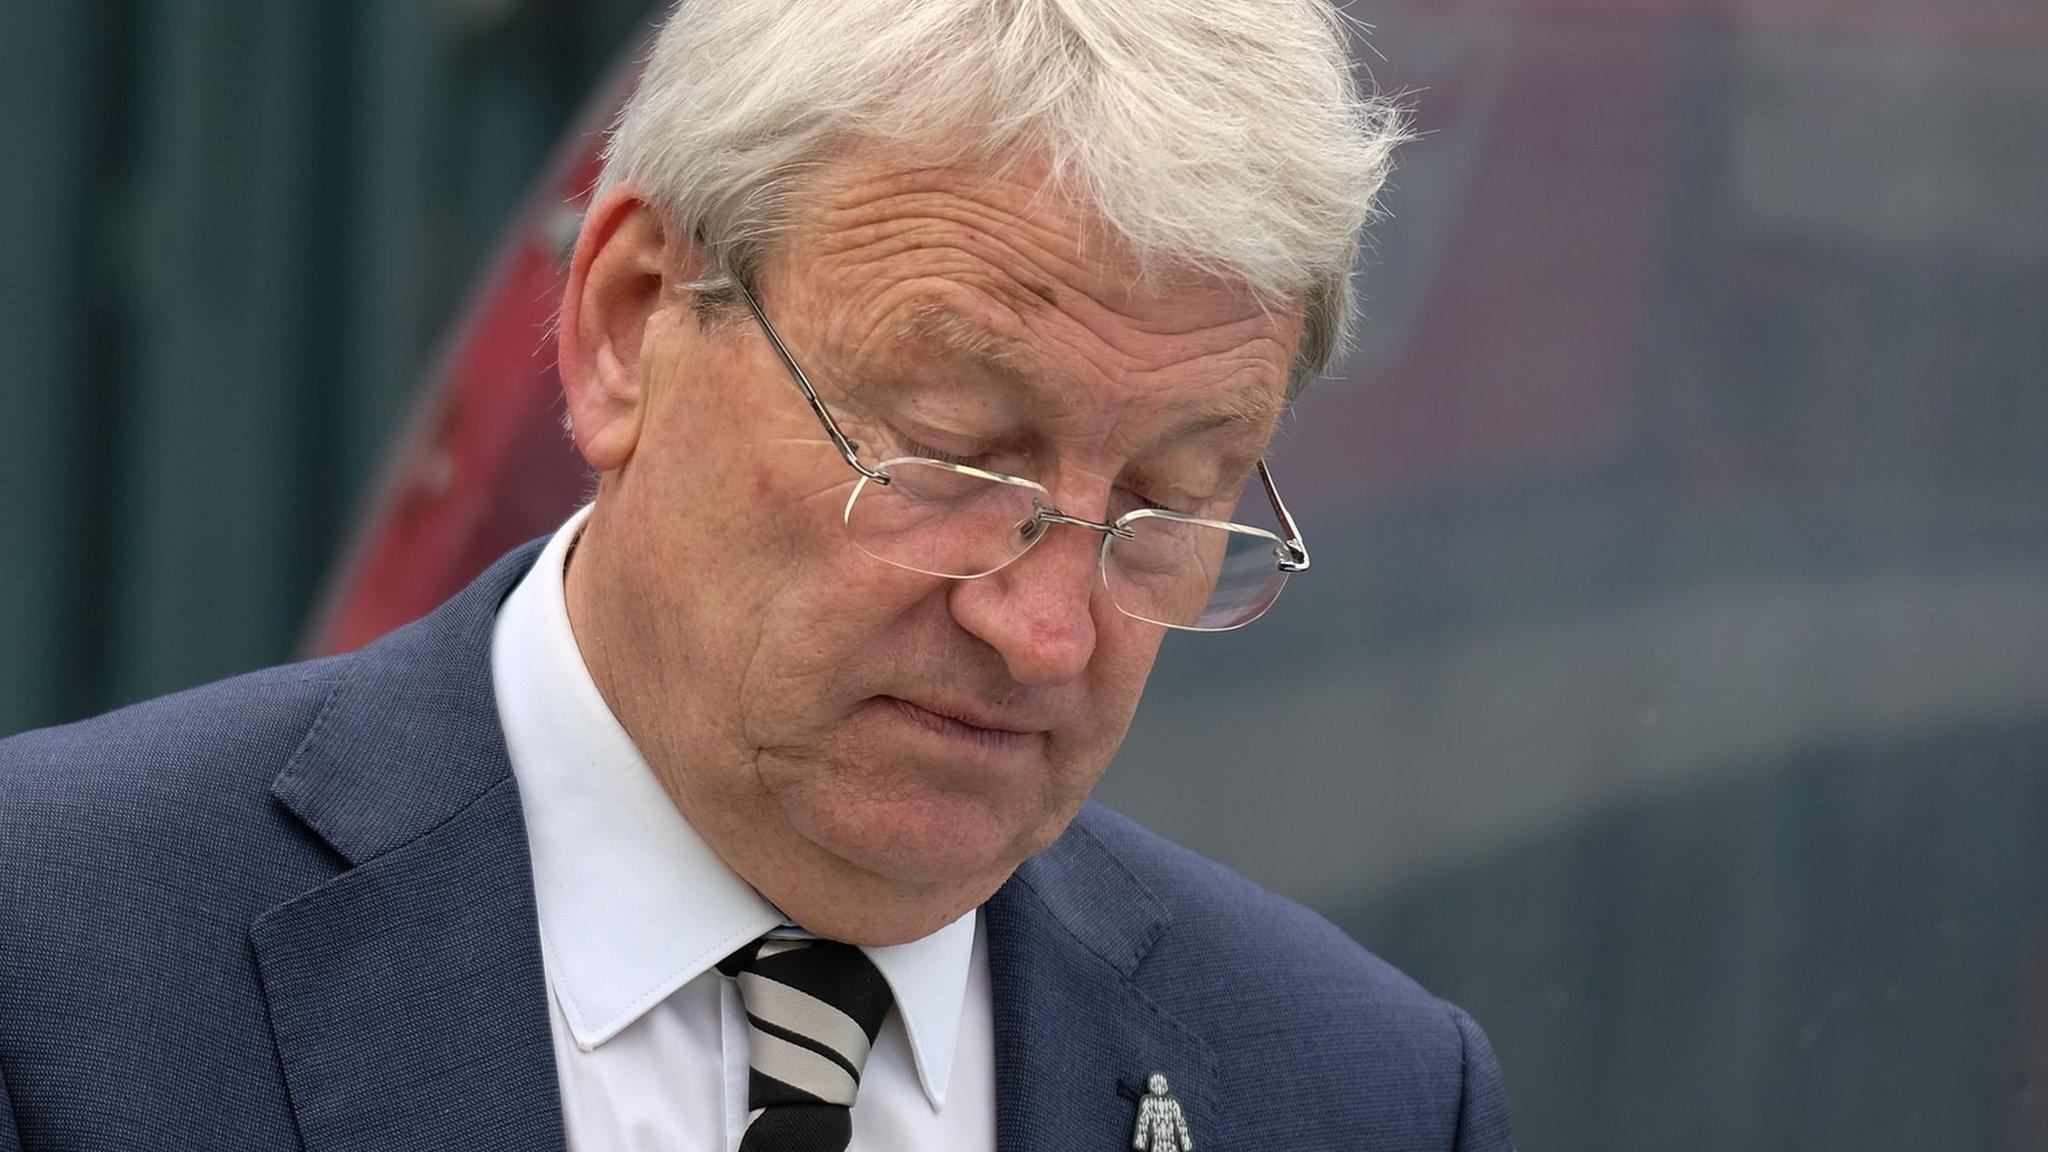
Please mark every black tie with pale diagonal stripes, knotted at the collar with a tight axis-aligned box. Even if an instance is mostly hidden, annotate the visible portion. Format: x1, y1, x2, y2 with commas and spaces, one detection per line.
719, 937, 889, 1152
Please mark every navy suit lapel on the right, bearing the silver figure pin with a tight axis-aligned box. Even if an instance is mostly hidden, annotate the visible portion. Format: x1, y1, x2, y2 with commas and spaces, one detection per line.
987, 818, 1221, 1152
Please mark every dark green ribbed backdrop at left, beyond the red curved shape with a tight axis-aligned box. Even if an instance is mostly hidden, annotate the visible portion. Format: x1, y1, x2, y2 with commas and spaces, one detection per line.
0, 0, 653, 732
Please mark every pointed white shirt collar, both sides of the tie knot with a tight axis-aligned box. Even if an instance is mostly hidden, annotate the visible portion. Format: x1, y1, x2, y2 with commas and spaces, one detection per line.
492, 506, 977, 1107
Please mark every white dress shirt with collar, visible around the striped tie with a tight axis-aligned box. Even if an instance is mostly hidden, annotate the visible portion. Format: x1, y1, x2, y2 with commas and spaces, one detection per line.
492, 506, 995, 1152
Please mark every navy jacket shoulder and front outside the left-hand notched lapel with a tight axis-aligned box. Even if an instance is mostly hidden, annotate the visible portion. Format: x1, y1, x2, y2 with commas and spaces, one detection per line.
0, 662, 382, 1148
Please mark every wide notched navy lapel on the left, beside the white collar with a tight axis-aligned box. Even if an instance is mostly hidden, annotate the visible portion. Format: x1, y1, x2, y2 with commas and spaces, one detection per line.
250, 543, 563, 1152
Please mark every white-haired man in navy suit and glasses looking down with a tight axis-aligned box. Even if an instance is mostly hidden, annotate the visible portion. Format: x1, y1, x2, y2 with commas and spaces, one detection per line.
0, 0, 1509, 1152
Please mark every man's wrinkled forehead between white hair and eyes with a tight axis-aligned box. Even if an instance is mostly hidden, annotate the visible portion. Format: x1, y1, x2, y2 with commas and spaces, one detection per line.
784, 142, 1300, 444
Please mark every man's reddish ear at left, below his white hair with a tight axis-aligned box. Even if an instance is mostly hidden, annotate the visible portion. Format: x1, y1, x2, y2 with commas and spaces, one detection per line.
557, 187, 694, 474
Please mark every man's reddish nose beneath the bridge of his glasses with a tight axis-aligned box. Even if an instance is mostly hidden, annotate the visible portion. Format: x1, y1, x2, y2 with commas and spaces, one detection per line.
948, 508, 1102, 687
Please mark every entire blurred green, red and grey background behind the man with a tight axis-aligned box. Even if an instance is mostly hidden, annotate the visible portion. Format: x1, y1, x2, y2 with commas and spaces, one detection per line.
0, 0, 2048, 1152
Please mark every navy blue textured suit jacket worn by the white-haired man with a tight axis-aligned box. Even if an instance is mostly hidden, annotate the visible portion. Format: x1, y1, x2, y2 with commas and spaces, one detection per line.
0, 541, 1509, 1152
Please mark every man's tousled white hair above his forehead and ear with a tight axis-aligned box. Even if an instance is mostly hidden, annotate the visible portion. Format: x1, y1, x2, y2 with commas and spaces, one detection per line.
600, 0, 1407, 394
